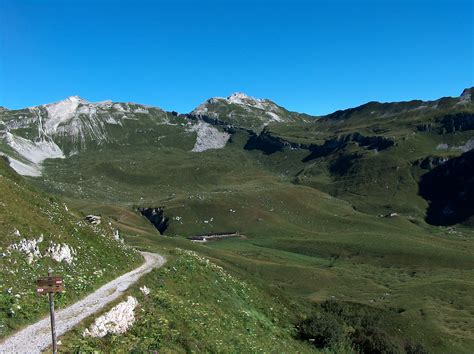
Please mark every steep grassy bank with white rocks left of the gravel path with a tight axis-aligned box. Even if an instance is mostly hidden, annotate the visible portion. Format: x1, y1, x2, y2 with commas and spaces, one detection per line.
0, 158, 142, 338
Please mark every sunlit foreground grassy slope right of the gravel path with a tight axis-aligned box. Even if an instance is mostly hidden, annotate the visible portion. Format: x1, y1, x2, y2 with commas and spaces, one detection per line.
56, 249, 311, 352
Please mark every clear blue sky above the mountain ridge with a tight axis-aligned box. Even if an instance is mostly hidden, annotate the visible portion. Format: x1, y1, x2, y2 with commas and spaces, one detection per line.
0, 0, 474, 114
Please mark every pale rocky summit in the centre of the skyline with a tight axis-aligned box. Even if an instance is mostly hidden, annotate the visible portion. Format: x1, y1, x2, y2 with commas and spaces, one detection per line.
190, 93, 314, 131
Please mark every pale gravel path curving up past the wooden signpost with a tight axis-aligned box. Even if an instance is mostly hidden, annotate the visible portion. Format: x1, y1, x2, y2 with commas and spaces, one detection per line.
0, 252, 166, 354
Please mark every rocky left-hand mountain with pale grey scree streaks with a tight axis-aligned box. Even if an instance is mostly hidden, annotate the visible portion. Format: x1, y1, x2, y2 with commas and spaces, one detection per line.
0, 96, 229, 177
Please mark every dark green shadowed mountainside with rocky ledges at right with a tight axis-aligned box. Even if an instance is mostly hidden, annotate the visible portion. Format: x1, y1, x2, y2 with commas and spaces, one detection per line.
247, 89, 474, 217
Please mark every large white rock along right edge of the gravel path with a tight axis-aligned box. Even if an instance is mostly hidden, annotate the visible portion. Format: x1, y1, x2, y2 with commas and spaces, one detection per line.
82, 296, 138, 338
